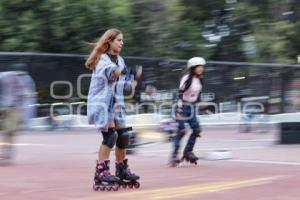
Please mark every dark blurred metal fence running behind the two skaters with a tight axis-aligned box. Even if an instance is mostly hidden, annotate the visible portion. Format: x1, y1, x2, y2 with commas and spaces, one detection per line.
0, 52, 300, 116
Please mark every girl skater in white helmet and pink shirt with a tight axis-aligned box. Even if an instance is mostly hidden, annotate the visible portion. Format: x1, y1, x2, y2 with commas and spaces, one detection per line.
170, 57, 206, 167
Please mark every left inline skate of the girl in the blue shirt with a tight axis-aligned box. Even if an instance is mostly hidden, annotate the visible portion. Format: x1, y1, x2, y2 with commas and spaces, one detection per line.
93, 160, 120, 191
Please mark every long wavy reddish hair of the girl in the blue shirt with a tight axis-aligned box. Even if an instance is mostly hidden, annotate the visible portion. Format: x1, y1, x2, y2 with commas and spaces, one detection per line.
85, 28, 122, 70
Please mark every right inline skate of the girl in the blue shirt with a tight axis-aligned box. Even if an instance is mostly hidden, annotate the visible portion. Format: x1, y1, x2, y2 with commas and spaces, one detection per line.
116, 159, 140, 188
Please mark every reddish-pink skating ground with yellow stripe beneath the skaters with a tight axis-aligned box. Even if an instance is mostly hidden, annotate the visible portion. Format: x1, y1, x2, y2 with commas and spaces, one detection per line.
0, 127, 300, 200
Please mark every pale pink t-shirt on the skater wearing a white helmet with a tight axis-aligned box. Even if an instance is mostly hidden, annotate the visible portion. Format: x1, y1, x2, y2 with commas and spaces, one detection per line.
179, 75, 202, 103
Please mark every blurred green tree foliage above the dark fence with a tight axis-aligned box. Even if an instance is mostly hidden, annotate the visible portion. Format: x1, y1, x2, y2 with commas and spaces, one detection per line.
0, 0, 300, 62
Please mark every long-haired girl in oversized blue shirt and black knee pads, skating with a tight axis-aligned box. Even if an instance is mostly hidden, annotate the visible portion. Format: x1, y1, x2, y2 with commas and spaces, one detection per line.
85, 29, 142, 190
